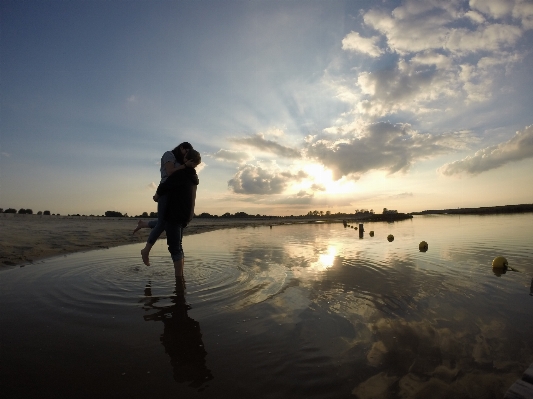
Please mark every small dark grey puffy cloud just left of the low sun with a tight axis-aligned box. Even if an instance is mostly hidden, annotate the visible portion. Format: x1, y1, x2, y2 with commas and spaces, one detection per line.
228, 165, 307, 194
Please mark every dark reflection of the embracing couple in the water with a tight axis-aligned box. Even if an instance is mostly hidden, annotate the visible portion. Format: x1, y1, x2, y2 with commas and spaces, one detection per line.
143, 278, 213, 388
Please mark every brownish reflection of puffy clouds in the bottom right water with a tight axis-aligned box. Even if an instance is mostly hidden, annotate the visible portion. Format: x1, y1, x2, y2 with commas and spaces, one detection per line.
352, 318, 531, 399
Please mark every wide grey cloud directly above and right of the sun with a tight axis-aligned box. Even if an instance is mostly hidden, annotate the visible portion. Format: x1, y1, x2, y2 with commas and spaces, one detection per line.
307, 123, 469, 180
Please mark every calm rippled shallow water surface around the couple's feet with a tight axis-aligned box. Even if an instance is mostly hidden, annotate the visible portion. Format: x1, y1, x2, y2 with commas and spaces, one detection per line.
0, 214, 533, 398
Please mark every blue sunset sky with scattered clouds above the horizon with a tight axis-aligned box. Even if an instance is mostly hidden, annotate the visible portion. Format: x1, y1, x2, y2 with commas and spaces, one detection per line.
0, 0, 533, 216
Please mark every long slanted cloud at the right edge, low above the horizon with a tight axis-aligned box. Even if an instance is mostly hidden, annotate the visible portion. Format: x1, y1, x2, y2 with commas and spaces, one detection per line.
438, 125, 533, 176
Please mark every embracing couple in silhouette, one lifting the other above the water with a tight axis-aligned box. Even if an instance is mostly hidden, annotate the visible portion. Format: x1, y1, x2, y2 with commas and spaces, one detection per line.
133, 142, 202, 279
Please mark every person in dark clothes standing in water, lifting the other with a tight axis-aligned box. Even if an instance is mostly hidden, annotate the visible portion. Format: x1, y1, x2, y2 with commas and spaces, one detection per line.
154, 149, 202, 279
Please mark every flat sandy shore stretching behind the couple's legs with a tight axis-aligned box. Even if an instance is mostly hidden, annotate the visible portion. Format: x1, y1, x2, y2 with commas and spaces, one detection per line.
0, 213, 328, 270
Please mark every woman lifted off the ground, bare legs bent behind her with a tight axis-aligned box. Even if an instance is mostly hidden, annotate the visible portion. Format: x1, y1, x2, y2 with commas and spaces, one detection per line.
133, 141, 192, 266
